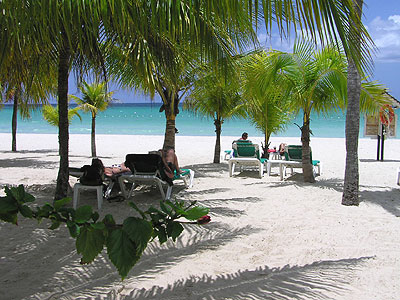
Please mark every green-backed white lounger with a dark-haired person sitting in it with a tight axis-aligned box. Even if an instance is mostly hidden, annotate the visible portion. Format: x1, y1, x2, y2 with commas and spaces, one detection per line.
228, 141, 267, 178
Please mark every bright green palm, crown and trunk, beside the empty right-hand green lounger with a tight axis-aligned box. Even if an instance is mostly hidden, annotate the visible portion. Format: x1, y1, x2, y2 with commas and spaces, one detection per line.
260, 42, 386, 182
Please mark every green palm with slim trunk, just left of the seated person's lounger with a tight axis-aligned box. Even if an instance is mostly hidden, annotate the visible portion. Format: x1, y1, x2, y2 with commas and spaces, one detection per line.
184, 72, 242, 163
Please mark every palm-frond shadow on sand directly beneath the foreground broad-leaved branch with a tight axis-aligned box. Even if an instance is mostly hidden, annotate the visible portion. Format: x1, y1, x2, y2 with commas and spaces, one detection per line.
18, 223, 258, 299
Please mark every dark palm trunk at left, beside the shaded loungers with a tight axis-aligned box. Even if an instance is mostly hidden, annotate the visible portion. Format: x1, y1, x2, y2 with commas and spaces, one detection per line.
54, 33, 71, 200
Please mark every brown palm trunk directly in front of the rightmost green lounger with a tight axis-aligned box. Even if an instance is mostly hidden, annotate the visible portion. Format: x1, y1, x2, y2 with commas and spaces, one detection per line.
301, 112, 315, 183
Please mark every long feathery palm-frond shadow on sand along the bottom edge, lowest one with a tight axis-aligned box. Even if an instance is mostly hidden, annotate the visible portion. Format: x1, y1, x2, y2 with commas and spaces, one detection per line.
113, 257, 371, 300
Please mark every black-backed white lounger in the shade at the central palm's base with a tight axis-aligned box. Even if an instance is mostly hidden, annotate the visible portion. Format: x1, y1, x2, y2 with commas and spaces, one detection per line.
118, 154, 194, 200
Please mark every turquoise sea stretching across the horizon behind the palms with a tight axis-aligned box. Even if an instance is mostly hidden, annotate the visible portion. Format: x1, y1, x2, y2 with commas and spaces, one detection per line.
0, 103, 400, 138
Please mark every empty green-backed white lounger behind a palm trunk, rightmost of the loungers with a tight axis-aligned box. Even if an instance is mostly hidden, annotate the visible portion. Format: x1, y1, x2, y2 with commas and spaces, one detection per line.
279, 145, 321, 180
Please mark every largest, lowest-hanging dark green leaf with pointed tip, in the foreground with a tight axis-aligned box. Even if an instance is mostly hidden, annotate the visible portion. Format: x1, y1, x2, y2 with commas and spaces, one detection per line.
107, 229, 139, 279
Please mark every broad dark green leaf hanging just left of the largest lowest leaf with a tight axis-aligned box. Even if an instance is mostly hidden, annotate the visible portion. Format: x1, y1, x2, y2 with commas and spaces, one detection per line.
76, 226, 105, 264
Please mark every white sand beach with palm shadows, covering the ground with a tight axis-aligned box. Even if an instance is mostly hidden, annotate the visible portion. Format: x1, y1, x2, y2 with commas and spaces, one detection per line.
0, 134, 400, 300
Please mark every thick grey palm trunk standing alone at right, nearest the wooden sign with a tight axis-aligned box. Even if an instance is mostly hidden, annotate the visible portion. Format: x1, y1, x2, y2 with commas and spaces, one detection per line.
342, 0, 363, 206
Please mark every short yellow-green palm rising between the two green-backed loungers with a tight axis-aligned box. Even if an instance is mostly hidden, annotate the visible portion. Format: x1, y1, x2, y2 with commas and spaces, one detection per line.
241, 52, 290, 153
